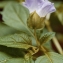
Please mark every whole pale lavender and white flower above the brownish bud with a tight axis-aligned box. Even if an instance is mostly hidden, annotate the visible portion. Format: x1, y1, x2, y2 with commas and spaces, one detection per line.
22, 0, 56, 17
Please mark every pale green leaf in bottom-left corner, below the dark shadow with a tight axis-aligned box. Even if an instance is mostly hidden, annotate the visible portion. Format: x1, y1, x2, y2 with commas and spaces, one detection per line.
0, 52, 34, 63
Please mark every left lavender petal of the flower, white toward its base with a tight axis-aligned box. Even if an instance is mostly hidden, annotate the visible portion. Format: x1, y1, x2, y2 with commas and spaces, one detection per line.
23, 0, 44, 13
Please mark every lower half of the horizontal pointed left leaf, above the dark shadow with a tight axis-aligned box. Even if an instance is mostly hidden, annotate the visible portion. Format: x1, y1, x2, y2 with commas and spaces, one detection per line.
0, 41, 31, 49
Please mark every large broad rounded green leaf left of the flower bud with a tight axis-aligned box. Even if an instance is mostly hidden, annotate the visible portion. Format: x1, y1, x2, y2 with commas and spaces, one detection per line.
2, 2, 30, 34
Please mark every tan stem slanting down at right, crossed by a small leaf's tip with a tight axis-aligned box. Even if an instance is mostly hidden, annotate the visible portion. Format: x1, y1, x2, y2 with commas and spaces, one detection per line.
45, 21, 63, 55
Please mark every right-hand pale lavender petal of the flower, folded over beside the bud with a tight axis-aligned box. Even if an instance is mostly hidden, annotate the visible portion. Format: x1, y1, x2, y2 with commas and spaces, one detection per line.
36, 1, 56, 17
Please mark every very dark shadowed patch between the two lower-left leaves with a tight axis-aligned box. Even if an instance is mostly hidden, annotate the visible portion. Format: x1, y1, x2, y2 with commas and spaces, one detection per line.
0, 45, 27, 58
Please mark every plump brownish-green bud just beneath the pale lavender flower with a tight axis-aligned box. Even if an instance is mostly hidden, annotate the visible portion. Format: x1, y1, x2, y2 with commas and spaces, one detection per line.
27, 12, 45, 29
